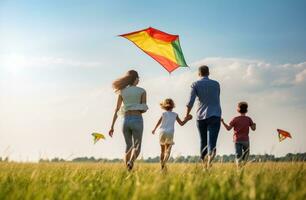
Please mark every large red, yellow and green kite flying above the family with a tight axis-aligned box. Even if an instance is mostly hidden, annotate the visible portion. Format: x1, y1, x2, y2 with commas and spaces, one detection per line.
119, 27, 188, 73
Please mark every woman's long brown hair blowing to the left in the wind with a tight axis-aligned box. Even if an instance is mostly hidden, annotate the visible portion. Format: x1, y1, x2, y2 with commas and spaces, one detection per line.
113, 70, 139, 92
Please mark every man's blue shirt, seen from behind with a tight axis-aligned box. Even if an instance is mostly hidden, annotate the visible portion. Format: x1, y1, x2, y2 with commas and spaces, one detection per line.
187, 76, 221, 120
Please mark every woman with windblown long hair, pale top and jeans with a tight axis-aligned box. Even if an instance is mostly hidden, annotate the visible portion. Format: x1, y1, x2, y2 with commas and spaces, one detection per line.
109, 70, 148, 170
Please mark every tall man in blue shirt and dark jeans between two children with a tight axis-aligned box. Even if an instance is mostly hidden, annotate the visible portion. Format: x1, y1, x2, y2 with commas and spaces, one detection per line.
186, 65, 221, 167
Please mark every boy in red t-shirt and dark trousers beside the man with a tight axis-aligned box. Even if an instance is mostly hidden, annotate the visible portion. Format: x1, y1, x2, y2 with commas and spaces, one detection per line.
221, 102, 256, 167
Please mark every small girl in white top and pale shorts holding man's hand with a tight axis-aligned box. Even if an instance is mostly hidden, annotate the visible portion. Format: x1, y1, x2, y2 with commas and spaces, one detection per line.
152, 99, 192, 169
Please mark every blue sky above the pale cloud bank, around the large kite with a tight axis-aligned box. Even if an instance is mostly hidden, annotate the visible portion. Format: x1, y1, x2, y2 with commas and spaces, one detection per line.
0, 0, 306, 63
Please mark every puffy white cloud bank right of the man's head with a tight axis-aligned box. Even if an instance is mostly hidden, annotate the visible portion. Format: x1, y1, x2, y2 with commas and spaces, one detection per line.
194, 58, 306, 90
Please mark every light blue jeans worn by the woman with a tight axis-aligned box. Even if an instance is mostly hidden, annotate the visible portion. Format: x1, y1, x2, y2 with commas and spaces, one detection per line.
122, 115, 143, 155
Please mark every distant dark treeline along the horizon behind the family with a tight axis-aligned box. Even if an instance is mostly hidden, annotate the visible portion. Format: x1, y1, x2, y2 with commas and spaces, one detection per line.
32, 152, 306, 163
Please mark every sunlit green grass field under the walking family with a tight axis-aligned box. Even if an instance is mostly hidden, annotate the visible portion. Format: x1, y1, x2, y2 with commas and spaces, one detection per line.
0, 162, 306, 200
